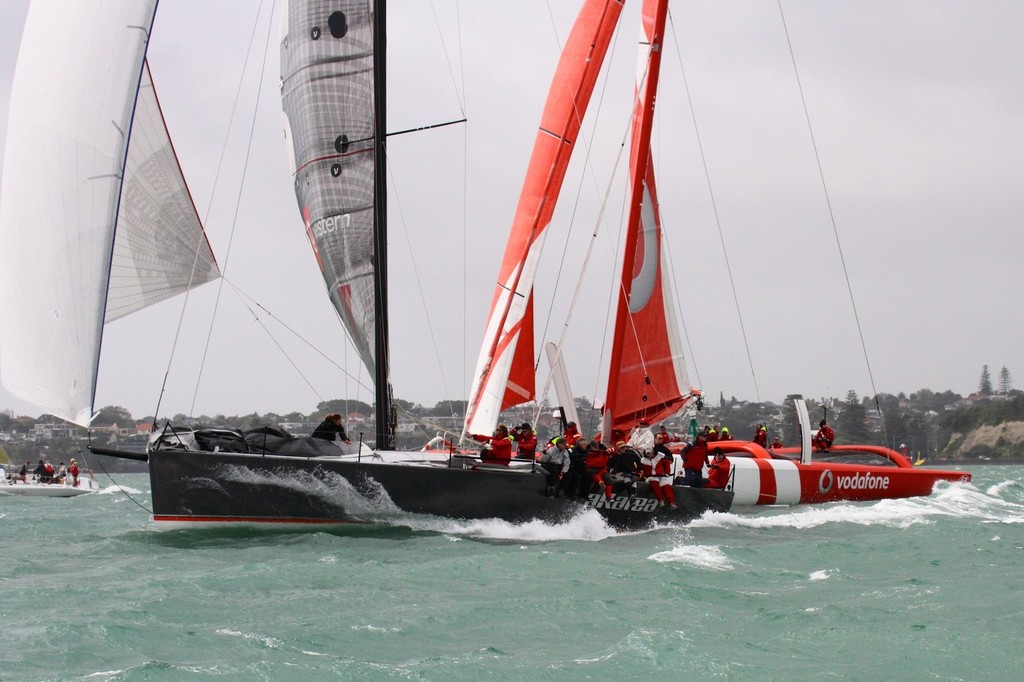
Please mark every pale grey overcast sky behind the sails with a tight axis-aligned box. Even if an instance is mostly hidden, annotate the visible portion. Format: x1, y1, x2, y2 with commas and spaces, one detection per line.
0, 0, 1024, 417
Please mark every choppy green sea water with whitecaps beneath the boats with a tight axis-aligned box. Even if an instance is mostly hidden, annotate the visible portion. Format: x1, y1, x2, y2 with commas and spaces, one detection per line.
0, 466, 1024, 682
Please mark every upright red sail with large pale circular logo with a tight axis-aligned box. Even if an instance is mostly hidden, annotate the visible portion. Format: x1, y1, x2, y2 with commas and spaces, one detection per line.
602, 0, 689, 438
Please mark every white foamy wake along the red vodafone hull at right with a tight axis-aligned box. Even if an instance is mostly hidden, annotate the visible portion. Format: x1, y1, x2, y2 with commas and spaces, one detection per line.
690, 475, 1024, 529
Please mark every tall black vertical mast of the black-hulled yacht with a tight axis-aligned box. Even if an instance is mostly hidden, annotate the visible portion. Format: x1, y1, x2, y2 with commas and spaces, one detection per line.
373, 0, 395, 450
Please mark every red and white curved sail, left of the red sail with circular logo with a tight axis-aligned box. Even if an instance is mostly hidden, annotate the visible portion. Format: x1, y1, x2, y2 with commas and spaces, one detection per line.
466, 0, 623, 433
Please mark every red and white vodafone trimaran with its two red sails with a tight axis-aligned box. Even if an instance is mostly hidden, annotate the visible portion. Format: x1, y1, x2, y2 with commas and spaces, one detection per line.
466, 0, 971, 508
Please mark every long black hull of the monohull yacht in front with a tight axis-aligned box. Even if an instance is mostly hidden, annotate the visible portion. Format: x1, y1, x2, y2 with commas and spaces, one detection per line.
150, 450, 732, 528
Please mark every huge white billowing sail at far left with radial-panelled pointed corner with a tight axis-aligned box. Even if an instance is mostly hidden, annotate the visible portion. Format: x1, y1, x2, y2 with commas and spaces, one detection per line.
0, 0, 215, 425
